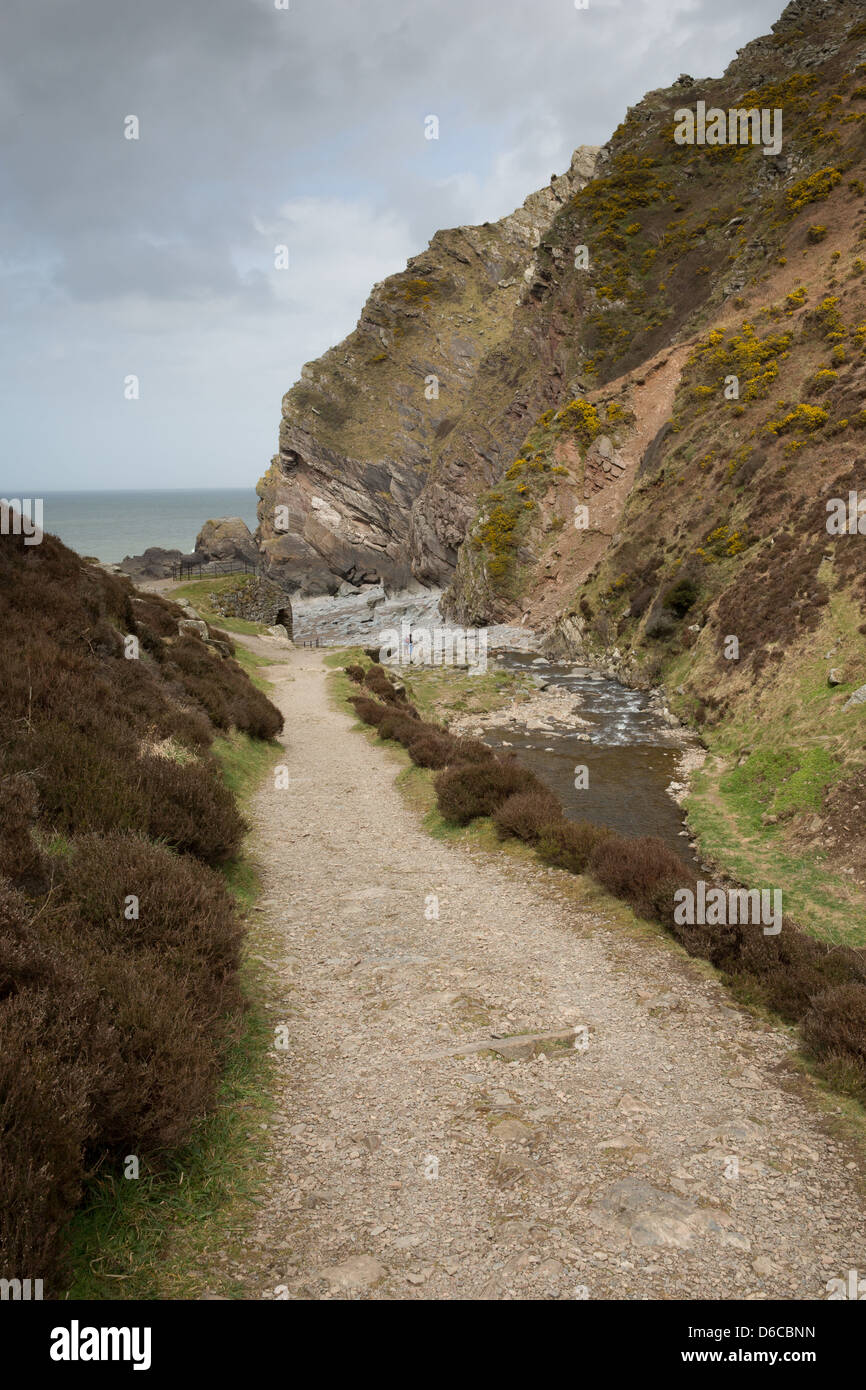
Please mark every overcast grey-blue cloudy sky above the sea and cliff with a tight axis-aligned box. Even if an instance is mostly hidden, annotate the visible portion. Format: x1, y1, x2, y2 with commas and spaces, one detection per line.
0, 0, 783, 495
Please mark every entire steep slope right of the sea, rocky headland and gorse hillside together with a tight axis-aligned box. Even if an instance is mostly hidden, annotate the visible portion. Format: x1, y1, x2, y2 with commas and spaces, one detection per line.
261, 0, 866, 887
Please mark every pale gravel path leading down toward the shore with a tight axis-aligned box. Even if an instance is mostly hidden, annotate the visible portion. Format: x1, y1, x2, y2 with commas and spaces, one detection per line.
222, 645, 866, 1300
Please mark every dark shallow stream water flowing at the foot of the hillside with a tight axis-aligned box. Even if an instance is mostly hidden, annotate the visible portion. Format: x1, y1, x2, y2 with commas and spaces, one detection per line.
484, 652, 696, 867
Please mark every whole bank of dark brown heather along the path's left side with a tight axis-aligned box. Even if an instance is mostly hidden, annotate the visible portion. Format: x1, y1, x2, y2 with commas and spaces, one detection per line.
0, 525, 282, 1297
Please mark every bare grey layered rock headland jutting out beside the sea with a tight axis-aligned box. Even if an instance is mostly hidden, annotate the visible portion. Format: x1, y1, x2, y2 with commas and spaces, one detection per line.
259, 147, 595, 594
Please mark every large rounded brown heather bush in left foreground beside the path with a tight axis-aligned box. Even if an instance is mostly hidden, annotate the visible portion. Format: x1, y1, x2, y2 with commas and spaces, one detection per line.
0, 834, 250, 1295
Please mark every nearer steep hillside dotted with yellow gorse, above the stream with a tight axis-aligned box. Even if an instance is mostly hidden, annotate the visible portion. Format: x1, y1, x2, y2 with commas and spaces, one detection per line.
446, 0, 866, 930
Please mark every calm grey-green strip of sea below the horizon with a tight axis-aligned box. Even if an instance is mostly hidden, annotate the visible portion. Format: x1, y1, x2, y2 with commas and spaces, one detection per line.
10, 488, 259, 564
